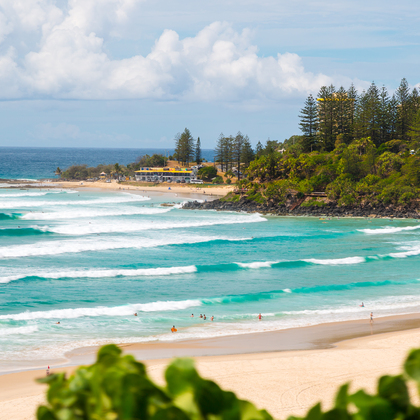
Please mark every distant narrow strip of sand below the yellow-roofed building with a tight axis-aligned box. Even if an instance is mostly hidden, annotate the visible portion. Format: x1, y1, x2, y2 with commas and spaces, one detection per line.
51, 181, 234, 198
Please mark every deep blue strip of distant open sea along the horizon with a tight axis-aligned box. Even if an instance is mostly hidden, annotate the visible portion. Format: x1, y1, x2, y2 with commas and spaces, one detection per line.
0, 147, 214, 179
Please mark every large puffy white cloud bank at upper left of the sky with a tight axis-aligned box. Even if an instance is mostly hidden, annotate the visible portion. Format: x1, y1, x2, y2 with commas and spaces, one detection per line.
0, 0, 348, 101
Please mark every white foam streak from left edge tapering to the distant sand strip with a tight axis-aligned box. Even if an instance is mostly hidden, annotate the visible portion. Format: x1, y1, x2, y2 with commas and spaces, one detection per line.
0, 193, 151, 209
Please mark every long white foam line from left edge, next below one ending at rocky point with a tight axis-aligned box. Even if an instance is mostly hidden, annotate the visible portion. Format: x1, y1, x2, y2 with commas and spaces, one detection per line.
0, 235, 250, 258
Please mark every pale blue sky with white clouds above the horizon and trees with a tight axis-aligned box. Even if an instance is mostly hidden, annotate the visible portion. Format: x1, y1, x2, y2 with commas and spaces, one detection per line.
0, 0, 420, 148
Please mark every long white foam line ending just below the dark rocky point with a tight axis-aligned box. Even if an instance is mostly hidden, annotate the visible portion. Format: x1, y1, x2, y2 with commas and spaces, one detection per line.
48, 215, 266, 235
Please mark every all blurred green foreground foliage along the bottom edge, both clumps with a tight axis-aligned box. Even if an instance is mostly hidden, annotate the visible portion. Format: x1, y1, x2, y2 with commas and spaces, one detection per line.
37, 344, 420, 420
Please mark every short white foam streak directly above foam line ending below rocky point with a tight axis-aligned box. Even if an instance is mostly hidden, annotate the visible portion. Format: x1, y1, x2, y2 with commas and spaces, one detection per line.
21, 207, 172, 220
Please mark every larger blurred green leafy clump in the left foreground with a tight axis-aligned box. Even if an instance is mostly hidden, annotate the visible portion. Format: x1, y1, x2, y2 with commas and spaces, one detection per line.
37, 344, 272, 420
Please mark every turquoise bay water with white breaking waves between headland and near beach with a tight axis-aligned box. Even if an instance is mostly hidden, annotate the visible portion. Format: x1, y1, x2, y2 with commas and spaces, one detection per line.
0, 188, 420, 370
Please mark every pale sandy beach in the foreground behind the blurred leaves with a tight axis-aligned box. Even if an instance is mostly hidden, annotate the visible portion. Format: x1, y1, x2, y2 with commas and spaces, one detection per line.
0, 315, 420, 420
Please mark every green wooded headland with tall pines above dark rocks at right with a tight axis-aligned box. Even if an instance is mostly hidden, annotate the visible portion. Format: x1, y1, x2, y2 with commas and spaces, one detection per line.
230, 79, 420, 207
